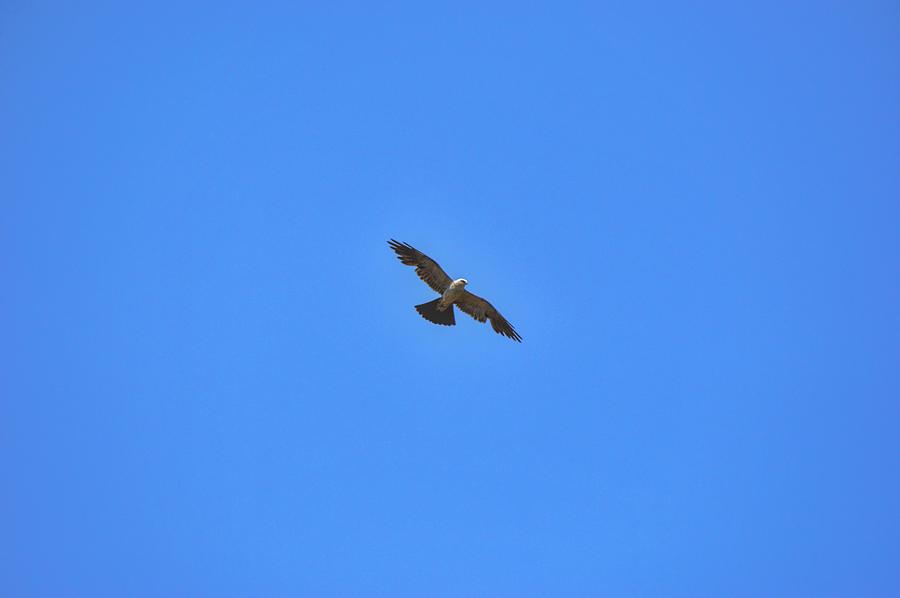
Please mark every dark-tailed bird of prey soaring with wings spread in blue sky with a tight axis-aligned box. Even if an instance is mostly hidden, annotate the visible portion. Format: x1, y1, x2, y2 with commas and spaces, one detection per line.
388, 239, 522, 343
